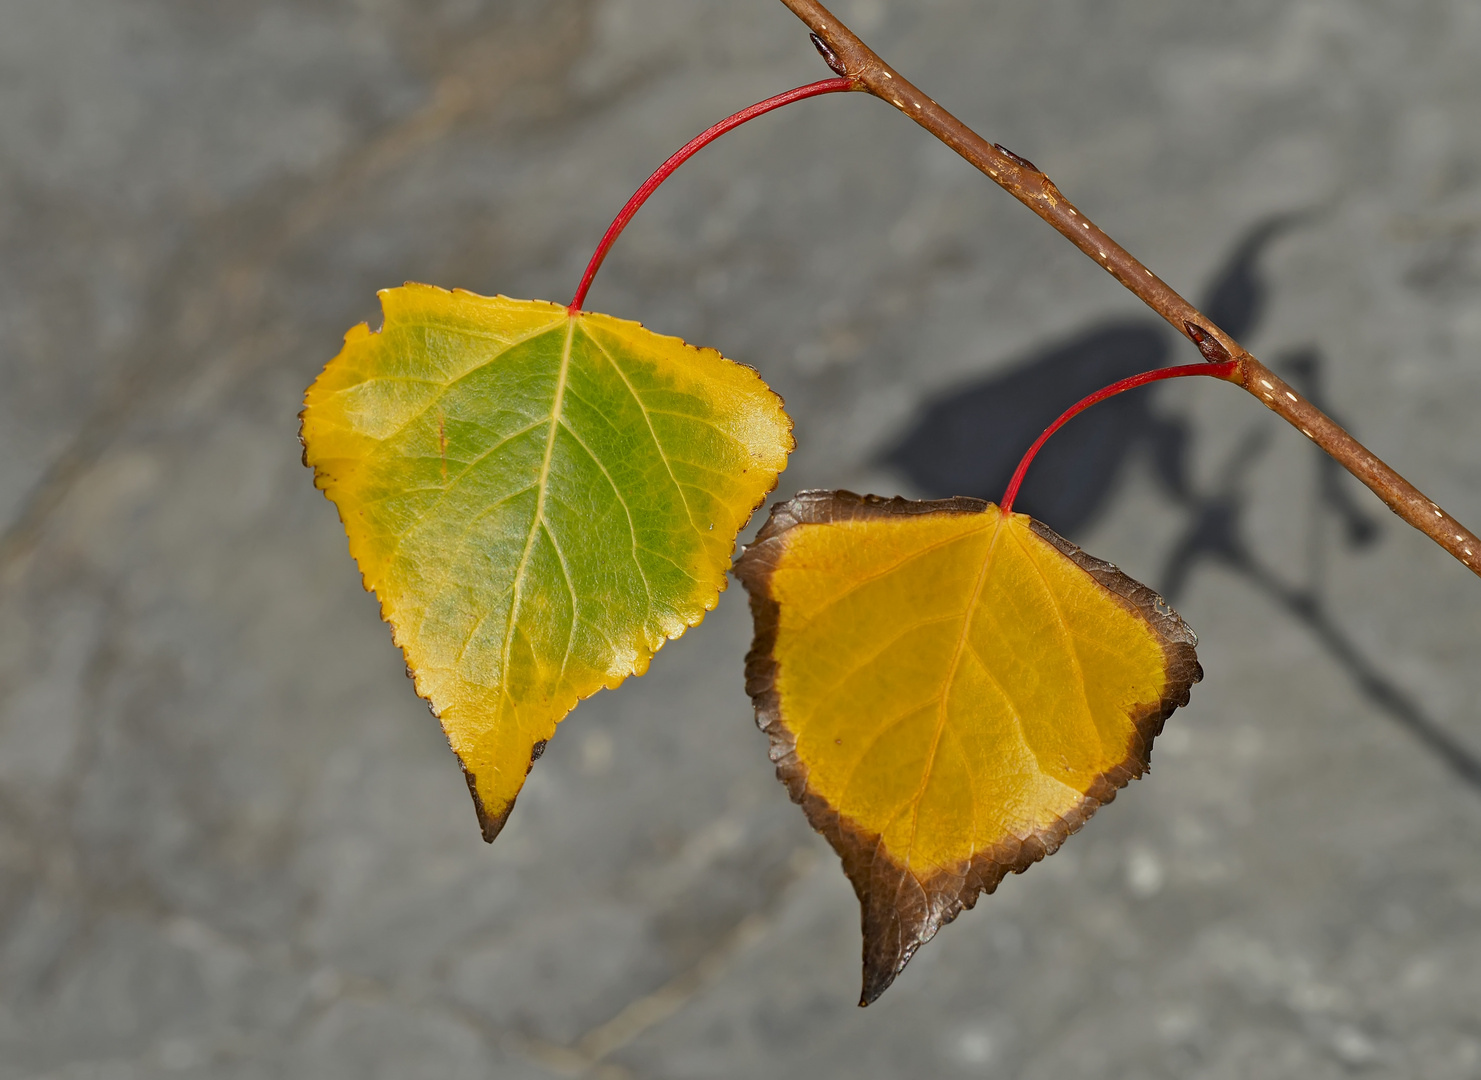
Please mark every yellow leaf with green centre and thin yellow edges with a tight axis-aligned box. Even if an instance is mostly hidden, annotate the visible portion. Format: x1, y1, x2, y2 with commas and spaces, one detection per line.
294, 284, 792, 840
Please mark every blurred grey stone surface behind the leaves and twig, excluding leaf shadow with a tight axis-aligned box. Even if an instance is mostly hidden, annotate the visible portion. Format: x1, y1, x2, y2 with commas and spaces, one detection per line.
0, 0, 1481, 1080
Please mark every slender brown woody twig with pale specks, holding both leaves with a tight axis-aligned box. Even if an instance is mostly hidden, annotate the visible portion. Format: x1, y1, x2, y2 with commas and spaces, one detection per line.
782, 0, 1481, 576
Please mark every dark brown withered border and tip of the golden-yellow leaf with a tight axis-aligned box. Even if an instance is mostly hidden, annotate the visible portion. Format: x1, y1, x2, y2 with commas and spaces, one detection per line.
735, 490, 1203, 1006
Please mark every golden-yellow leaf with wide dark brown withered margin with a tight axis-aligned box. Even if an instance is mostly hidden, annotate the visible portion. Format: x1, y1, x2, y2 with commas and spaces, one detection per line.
736, 492, 1203, 1004
